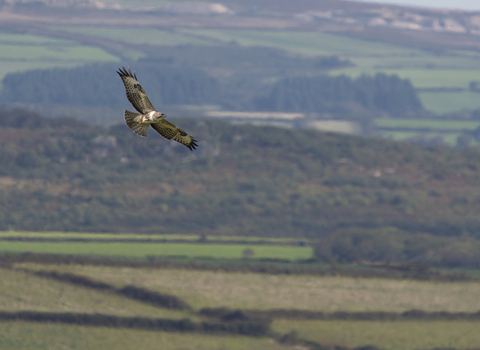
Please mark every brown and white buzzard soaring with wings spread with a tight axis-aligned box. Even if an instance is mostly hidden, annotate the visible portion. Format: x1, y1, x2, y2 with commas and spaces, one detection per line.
117, 67, 198, 151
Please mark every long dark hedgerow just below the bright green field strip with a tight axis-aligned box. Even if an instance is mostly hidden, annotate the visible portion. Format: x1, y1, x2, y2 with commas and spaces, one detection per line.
0, 253, 477, 282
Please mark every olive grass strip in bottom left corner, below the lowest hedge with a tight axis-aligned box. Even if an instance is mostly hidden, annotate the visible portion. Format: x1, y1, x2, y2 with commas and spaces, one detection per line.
0, 322, 291, 350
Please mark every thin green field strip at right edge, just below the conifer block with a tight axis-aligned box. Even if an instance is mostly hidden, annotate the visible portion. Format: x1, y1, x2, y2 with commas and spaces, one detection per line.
375, 119, 480, 130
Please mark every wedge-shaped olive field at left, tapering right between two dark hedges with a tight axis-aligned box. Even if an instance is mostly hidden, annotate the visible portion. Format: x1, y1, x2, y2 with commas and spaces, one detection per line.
0, 269, 190, 318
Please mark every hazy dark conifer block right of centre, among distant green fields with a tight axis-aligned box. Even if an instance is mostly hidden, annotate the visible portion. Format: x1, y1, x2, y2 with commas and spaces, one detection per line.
255, 73, 423, 116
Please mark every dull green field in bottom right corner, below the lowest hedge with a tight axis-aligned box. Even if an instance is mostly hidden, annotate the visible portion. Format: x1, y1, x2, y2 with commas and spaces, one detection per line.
272, 320, 480, 350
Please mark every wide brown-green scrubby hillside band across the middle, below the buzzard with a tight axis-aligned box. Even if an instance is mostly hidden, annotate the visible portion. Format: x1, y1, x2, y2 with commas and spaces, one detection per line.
0, 110, 480, 266
